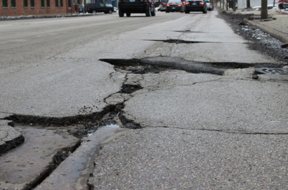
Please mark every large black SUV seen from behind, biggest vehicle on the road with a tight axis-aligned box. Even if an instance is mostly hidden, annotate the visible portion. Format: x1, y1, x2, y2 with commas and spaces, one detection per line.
118, 0, 156, 17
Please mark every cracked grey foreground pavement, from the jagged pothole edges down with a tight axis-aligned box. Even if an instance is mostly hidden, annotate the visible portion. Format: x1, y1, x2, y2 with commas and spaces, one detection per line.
0, 57, 288, 189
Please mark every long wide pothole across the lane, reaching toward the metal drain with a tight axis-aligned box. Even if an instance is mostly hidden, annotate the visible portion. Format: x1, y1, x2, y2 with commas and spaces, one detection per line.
101, 57, 284, 75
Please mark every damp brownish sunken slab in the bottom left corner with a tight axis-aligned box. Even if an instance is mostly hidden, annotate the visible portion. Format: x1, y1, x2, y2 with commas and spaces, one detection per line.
0, 126, 80, 189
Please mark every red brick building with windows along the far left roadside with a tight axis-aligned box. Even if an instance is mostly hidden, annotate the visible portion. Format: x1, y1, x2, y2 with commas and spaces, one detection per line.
0, 0, 82, 16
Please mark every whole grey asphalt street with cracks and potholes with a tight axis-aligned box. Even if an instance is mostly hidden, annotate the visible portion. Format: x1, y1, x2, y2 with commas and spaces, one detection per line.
0, 10, 288, 190
